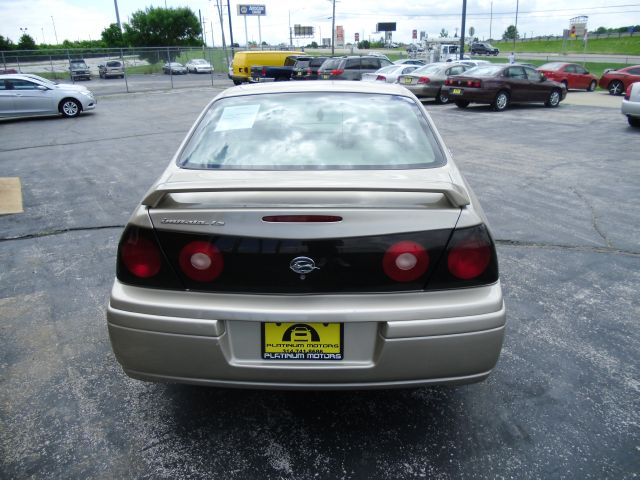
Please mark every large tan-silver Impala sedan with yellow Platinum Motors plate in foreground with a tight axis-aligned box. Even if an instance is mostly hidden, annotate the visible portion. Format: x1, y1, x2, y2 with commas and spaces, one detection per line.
107, 82, 506, 389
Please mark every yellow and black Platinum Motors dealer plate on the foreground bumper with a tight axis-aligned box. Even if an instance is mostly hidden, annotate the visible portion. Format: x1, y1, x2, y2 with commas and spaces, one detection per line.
262, 323, 344, 360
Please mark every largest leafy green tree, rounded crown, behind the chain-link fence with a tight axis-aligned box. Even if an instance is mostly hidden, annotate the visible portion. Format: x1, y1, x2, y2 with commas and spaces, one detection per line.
124, 7, 202, 47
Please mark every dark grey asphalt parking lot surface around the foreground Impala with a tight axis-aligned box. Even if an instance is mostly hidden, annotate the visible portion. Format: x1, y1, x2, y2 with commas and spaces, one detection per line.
0, 82, 640, 479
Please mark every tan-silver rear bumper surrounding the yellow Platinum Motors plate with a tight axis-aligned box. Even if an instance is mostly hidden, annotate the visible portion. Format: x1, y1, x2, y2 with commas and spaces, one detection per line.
107, 280, 506, 389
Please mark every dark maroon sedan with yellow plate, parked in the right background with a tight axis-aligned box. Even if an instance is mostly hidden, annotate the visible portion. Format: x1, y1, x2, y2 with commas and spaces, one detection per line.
442, 64, 567, 112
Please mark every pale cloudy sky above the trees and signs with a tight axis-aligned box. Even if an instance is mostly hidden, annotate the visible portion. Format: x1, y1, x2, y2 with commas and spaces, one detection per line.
0, 0, 640, 46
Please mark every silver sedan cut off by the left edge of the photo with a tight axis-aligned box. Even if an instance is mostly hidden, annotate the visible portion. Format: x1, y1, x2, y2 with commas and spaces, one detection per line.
0, 74, 98, 117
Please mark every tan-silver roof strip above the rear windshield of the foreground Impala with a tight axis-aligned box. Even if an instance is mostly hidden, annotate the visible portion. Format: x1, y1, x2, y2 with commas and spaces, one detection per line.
218, 80, 412, 98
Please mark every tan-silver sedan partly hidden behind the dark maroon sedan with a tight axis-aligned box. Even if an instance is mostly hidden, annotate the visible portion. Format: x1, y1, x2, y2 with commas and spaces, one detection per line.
398, 62, 472, 103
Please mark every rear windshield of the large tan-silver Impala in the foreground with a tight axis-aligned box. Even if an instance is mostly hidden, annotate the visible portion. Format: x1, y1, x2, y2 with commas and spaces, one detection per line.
178, 92, 445, 170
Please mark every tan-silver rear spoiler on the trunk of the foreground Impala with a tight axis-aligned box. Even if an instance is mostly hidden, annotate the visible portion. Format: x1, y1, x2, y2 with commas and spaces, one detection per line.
142, 182, 471, 208
